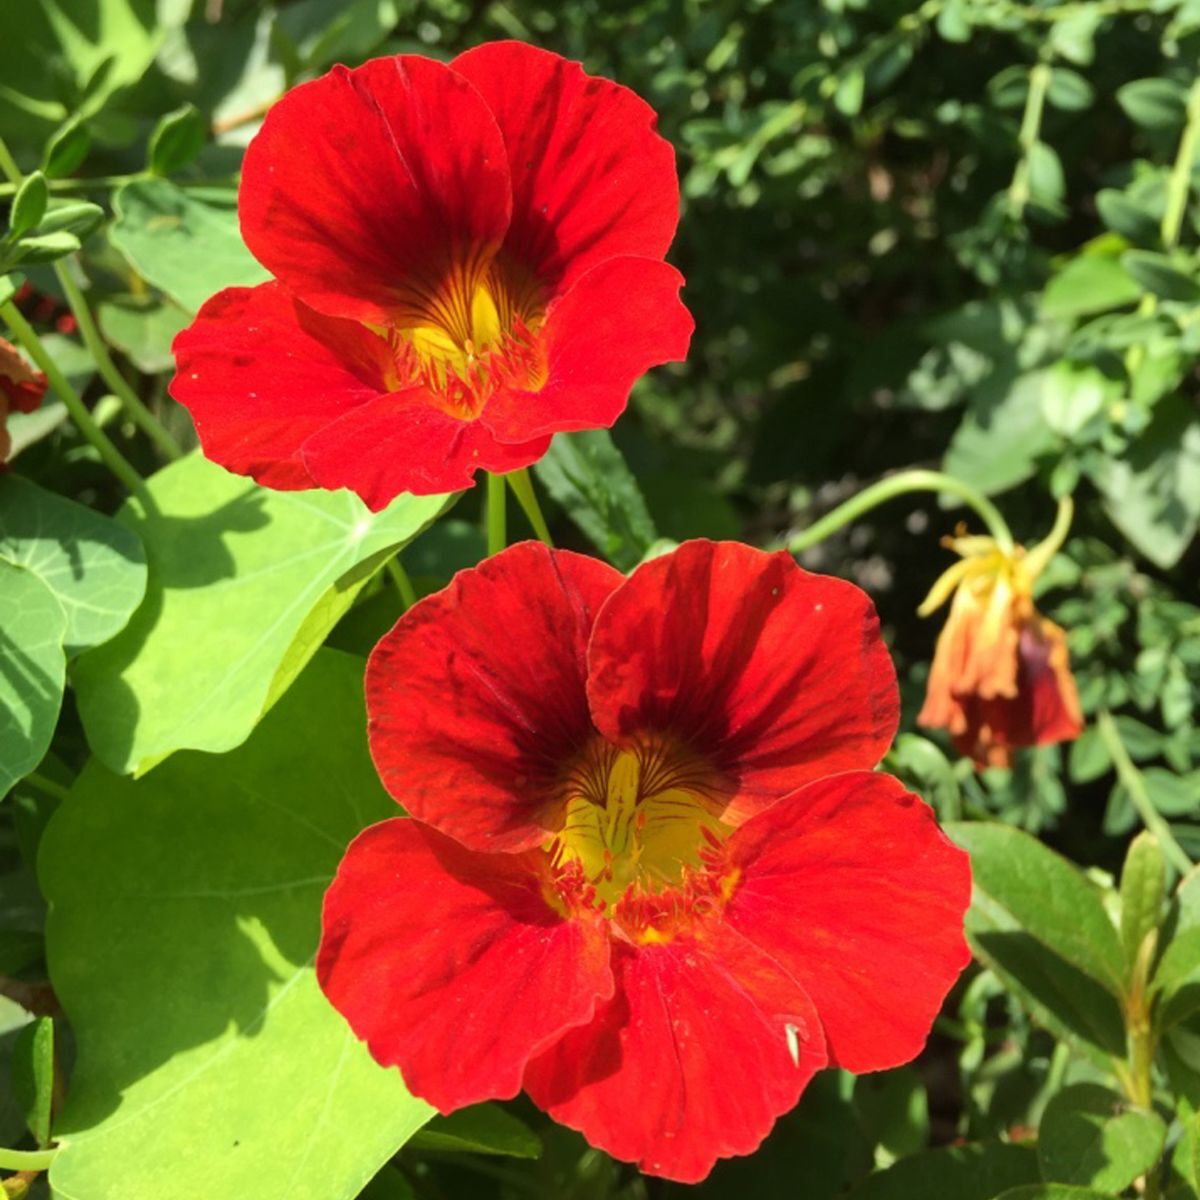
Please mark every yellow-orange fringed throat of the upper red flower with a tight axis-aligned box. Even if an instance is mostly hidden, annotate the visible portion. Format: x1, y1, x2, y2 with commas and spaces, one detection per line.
390, 256, 546, 420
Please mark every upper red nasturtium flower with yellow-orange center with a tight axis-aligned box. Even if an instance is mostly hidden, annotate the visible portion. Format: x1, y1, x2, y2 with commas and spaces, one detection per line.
170, 42, 692, 509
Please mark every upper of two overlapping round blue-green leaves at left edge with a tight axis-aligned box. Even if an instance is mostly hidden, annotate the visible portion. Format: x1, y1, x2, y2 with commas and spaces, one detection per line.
0, 474, 146, 656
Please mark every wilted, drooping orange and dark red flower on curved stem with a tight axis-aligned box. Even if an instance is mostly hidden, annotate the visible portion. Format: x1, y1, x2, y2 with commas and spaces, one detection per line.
917, 499, 1084, 767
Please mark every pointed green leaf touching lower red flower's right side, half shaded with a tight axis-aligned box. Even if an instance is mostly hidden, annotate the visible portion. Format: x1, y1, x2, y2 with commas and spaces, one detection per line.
947, 822, 1124, 1055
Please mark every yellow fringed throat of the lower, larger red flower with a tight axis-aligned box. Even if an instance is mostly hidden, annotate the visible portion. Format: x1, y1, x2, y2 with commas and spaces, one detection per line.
544, 736, 736, 943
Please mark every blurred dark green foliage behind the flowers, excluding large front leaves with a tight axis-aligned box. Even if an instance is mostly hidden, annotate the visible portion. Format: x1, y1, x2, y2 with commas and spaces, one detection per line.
0, 0, 1200, 1200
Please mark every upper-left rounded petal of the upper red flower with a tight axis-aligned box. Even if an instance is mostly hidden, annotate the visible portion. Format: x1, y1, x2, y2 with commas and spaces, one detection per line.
239, 54, 511, 323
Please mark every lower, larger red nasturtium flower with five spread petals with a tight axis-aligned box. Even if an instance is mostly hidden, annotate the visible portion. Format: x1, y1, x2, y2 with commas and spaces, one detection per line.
317, 541, 970, 1181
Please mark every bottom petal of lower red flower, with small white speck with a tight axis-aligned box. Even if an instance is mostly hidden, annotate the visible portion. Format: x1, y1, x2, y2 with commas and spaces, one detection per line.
526, 925, 826, 1183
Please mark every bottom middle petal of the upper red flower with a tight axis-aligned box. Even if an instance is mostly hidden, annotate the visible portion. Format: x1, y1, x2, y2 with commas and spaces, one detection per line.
302, 385, 550, 511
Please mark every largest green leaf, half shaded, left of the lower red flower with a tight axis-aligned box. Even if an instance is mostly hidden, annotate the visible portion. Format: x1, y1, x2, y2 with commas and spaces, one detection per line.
40, 650, 431, 1200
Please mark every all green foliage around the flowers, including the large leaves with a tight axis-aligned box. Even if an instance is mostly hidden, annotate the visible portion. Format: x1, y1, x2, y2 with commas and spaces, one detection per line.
0, 0, 1200, 1200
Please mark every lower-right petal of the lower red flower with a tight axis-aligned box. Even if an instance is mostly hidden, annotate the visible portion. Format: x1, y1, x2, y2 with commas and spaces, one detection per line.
725, 772, 971, 1072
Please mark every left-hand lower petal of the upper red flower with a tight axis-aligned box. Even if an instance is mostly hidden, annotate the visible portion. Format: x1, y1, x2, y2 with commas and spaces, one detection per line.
170, 283, 388, 490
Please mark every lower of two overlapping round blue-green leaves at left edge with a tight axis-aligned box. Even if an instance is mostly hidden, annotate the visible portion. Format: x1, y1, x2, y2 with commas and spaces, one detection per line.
0, 558, 67, 796
